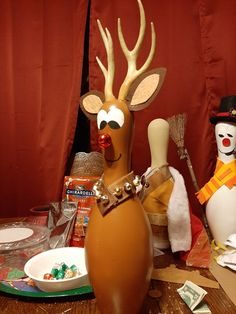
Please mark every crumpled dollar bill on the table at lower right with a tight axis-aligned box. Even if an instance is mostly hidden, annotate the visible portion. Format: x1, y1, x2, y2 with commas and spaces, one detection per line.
177, 280, 211, 314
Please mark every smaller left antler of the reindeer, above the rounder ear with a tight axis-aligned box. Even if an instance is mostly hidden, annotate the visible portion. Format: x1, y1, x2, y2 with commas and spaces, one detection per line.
96, 20, 115, 100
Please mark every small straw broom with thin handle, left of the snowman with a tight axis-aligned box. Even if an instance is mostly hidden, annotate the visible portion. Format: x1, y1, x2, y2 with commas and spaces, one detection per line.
167, 113, 212, 239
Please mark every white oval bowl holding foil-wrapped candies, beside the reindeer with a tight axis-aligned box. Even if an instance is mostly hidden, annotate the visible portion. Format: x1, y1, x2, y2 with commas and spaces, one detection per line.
24, 247, 89, 292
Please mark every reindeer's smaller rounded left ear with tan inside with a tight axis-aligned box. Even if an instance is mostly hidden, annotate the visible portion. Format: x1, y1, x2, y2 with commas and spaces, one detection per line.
80, 91, 104, 120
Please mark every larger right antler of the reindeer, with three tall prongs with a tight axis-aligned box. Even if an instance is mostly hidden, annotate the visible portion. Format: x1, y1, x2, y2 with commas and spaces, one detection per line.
118, 0, 156, 100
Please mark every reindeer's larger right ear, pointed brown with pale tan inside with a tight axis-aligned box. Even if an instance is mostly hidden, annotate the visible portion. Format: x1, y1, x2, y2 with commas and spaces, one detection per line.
126, 68, 166, 111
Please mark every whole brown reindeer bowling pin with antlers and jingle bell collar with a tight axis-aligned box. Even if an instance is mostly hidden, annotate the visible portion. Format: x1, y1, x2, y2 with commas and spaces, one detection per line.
80, 0, 165, 314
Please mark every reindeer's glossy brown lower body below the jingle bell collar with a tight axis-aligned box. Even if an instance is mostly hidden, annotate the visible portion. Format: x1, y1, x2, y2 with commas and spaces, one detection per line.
85, 197, 153, 314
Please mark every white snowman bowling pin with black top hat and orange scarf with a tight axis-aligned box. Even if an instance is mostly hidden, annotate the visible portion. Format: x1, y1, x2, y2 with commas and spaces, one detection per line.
197, 96, 236, 244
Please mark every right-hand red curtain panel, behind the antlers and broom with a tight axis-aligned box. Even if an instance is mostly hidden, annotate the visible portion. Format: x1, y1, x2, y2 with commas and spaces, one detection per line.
89, 0, 236, 213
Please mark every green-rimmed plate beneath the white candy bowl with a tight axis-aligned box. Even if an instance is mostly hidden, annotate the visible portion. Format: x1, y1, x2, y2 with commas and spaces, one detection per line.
0, 279, 93, 298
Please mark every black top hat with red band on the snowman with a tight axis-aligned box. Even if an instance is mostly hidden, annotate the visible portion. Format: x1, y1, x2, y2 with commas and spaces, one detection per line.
210, 96, 236, 124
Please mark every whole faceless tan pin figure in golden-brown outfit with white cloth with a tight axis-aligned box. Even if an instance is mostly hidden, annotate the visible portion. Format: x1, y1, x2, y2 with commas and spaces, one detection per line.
140, 119, 192, 252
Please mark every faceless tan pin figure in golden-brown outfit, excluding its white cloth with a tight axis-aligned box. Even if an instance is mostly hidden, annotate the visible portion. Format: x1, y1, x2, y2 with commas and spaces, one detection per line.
140, 119, 173, 249
